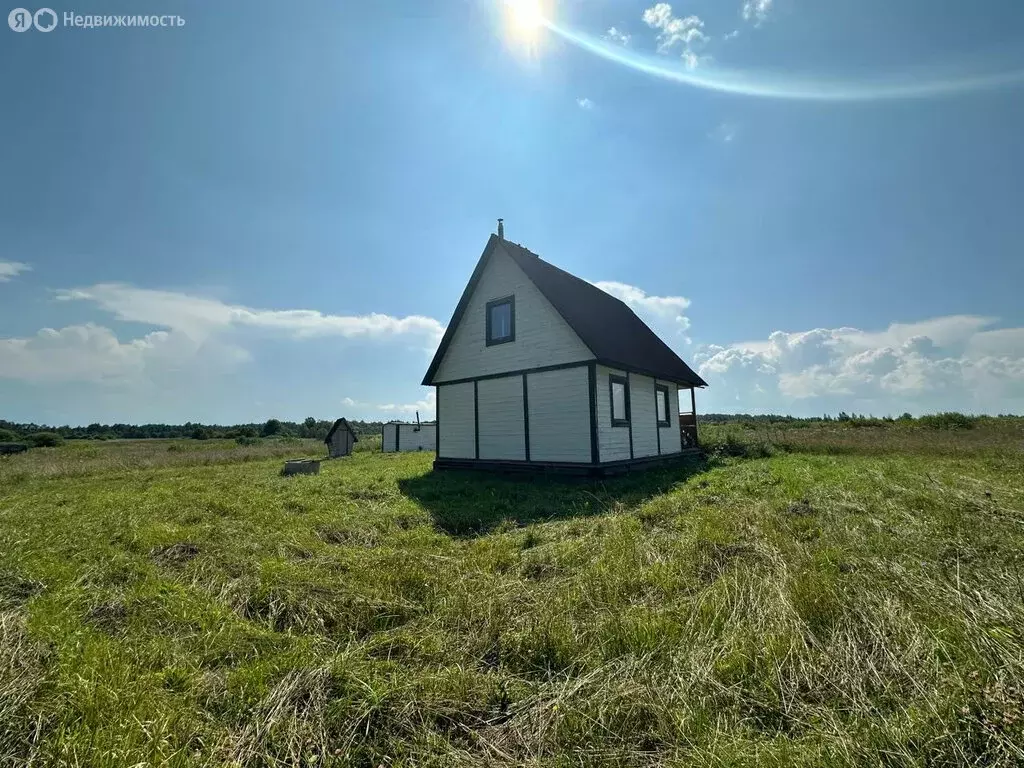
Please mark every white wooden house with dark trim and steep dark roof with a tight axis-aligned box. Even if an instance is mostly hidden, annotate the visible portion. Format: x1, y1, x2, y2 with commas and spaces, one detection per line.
423, 220, 707, 474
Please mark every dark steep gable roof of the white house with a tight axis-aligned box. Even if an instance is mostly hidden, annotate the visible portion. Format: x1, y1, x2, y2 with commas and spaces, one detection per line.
423, 234, 708, 387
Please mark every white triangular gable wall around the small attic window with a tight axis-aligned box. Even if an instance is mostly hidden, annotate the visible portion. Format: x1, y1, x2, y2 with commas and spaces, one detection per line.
434, 250, 594, 382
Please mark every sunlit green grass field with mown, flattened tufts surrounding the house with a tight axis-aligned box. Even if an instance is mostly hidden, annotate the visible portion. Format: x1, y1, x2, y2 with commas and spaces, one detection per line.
0, 428, 1024, 767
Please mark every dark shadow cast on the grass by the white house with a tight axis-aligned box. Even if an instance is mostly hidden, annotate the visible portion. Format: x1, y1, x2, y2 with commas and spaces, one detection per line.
398, 458, 715, 537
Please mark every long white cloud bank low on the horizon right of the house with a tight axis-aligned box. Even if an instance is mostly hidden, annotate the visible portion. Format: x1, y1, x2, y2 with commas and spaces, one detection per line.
694, 315, 1024, 415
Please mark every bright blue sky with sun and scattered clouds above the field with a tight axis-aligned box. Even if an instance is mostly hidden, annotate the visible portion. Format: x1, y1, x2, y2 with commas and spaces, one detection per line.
0, 0, 1024, 424
